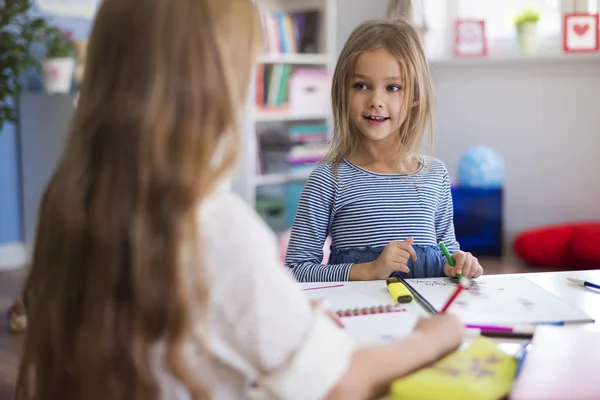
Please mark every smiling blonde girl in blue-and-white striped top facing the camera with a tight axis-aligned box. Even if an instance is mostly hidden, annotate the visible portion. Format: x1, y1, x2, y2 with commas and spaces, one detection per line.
286, 19, 483, 281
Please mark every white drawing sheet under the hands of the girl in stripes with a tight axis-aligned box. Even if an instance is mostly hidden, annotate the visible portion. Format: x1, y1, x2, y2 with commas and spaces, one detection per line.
407, 276, 593, 325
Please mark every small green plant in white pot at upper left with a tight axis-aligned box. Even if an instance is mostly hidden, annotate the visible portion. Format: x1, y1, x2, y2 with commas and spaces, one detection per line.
41, 26, 75, 94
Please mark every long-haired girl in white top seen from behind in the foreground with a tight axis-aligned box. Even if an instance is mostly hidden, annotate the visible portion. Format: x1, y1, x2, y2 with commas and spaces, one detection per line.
16, 0, 462, 400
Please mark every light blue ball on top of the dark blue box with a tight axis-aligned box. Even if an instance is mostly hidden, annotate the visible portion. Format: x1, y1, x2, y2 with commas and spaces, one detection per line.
458, 146, 505, 189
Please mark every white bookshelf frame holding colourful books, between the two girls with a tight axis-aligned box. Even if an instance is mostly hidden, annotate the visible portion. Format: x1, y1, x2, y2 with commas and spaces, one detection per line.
234, 0, 337, 212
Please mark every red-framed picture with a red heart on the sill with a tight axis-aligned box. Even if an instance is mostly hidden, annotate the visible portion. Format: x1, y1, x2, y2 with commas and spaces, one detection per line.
563, 13, 600, 53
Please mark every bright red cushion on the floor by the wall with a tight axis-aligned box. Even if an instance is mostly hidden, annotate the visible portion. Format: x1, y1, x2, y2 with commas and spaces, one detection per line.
513, 222, 600, 269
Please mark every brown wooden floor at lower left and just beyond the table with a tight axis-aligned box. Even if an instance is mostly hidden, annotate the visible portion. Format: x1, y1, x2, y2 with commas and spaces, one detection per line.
0, 259, 548, 400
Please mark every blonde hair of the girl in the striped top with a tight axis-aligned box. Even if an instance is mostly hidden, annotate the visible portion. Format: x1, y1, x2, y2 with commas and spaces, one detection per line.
326, 19, 433, 164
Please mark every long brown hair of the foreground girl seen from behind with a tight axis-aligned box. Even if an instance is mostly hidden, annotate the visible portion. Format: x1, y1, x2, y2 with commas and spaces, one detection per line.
16, 0, 260, 400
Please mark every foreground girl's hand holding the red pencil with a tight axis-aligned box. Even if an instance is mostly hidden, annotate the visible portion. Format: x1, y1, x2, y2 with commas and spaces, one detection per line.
414, 313, 466, 357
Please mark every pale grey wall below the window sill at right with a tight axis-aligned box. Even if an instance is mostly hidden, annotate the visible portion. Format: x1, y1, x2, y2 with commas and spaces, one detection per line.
432, 55, 600, 250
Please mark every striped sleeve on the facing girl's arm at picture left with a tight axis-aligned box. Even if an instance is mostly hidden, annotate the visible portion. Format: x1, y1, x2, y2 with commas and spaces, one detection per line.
285, 165, 352, 282
